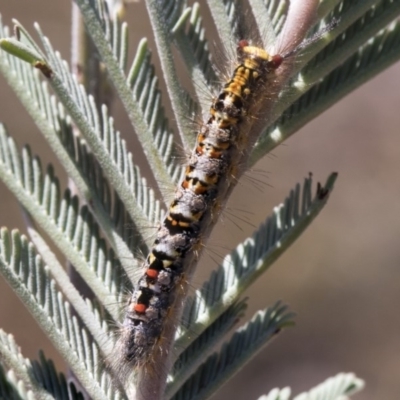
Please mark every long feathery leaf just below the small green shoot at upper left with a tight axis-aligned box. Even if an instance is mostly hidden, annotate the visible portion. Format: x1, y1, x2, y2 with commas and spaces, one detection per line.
0, 23, 145, 273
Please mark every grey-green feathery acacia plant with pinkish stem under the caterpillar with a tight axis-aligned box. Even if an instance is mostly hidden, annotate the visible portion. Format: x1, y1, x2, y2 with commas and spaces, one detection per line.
0, 0, 400, 400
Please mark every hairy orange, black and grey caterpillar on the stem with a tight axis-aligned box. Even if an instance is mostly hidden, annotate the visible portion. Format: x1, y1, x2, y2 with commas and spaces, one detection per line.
114, 40, 284, 378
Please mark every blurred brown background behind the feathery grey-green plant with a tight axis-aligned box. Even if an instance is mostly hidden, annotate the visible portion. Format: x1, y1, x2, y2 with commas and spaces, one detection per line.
0, 0, 400, 400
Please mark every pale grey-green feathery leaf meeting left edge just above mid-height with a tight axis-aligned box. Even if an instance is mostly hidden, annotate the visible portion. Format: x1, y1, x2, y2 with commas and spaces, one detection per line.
0, 126, 124, 320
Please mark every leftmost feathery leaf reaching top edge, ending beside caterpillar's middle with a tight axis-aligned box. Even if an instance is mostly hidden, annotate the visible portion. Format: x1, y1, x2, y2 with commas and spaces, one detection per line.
76, 0, 181, 191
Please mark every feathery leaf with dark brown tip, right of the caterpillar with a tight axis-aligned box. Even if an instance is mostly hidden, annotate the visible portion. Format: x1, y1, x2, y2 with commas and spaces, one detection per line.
175, 174, 337, 352
